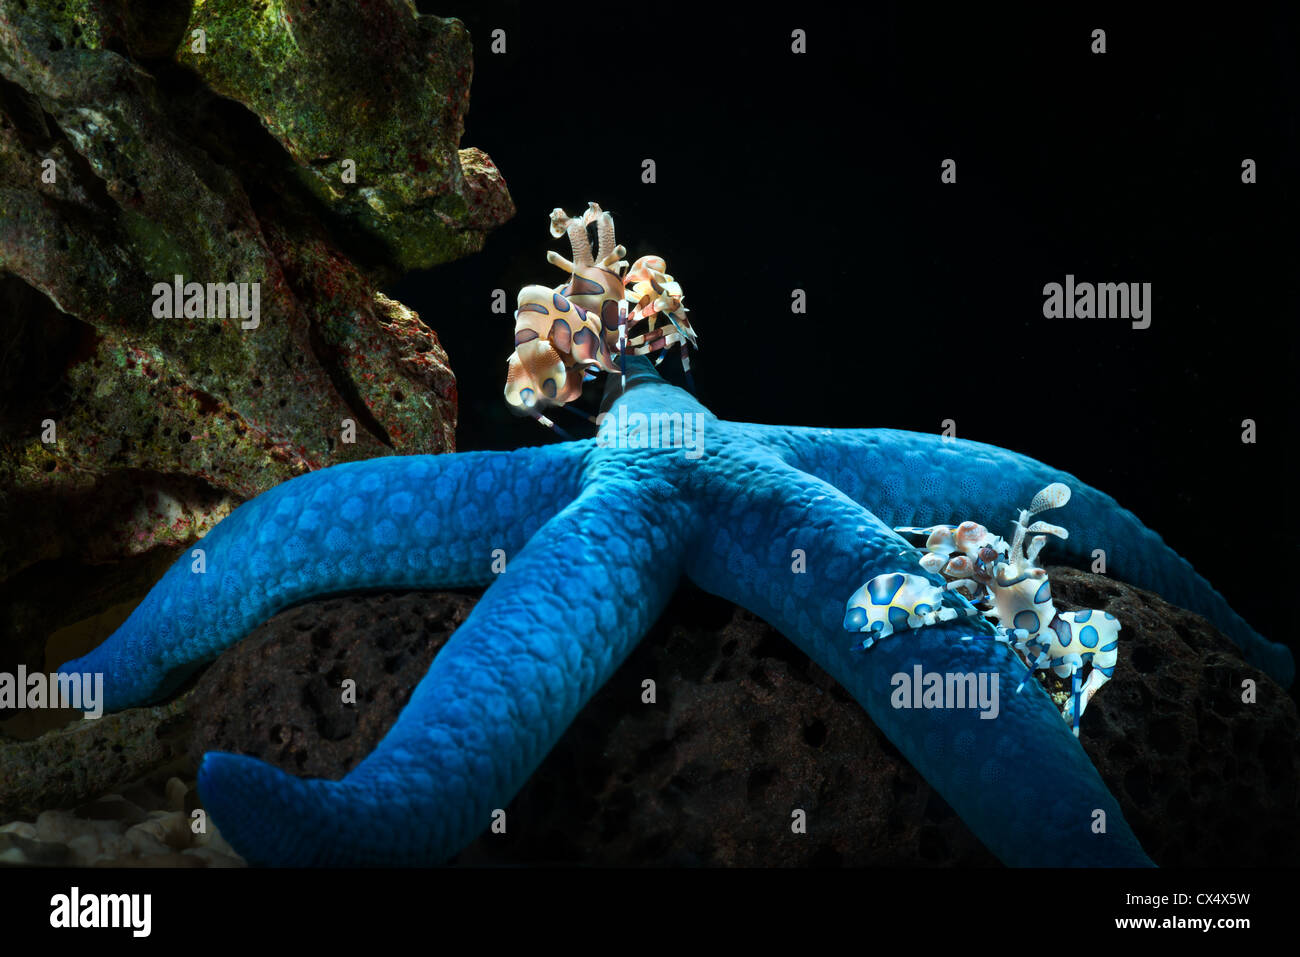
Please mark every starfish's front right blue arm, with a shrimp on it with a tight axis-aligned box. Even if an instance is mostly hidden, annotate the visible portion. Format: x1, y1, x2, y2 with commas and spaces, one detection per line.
686, 454, 1151, 866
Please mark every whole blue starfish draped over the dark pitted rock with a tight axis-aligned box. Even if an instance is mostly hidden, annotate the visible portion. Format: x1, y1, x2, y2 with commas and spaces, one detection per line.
62, 359, 1294, 866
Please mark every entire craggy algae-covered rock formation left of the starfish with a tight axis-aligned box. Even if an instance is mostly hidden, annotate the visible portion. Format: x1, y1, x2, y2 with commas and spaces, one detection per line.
0, 0, 514, 686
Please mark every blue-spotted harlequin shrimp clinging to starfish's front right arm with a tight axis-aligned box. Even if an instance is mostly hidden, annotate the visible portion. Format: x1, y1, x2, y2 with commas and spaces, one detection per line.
894, 482, 1119, 736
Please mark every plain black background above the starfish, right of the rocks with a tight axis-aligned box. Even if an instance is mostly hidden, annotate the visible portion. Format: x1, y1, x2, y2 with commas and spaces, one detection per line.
386, 0, 1300, 670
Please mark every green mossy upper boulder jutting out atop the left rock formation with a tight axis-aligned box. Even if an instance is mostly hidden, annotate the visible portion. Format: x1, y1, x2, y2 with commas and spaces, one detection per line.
178, 0, 512, 268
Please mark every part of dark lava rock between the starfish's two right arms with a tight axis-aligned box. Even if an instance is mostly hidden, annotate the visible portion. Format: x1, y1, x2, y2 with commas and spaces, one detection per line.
1048, 568, 1300, 867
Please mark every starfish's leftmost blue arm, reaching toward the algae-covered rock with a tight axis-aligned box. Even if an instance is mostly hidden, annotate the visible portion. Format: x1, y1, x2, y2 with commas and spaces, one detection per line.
60, 442, 590, 711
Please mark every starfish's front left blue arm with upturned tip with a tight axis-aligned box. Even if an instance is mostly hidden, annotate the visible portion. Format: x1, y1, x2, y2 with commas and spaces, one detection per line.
199, 469, 686, 866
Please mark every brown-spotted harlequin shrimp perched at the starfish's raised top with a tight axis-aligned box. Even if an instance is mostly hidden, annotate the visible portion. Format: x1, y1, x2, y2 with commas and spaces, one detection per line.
506, 203, 696, 430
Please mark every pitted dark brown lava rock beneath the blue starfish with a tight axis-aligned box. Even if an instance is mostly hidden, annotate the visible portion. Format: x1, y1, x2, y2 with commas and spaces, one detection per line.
178, 568, 1300, 866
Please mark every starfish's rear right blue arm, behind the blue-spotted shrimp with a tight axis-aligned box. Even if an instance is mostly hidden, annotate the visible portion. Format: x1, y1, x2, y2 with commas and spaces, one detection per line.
750, 426, 1295, 687
